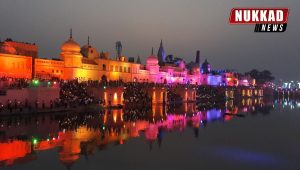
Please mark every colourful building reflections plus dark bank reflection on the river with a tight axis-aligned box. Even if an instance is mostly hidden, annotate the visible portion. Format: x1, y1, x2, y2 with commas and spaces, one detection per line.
0, 99, 280, 168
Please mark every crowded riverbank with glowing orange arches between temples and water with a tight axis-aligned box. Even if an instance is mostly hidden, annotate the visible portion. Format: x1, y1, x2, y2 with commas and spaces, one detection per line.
0, 81, 273, 115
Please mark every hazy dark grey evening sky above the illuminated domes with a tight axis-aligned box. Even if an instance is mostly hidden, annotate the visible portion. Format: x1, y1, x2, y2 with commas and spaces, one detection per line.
0, 0, 300, 80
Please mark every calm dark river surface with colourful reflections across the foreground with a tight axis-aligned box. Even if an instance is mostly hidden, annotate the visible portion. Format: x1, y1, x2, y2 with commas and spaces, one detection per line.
0, 101, 300, 170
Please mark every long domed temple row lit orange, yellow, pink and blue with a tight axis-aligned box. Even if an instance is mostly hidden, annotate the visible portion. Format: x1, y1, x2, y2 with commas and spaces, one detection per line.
0, 31, 252, 86
